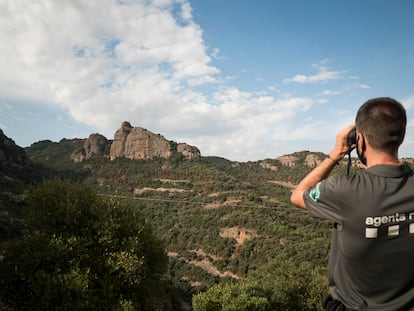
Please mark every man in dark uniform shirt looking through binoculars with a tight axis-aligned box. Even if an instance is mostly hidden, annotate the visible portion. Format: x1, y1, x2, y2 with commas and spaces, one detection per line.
291, 98, 414, 311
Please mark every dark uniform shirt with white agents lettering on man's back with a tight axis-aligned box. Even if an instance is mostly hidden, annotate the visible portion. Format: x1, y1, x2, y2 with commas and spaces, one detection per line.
304, 164, 414, 310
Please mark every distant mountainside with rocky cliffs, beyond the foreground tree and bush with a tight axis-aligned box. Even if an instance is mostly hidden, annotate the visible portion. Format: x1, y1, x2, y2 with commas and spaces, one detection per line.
4, 127, 414, 309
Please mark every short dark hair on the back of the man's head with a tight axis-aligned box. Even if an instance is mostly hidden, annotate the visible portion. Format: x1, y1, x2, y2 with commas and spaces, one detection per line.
355, 97, 407, 153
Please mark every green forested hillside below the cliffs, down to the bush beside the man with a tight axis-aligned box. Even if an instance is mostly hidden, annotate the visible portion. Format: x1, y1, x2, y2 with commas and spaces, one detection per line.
0, 133, 372, 310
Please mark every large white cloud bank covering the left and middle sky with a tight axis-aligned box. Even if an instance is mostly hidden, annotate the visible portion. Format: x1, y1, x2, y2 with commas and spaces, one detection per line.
0, 0, 368, 160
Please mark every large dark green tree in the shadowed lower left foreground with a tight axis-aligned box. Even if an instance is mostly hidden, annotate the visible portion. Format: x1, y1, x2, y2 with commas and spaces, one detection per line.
0, 180, 173, 310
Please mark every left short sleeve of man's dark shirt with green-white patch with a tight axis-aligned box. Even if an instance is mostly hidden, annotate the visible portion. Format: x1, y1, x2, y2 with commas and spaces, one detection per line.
303, 177, 345, 224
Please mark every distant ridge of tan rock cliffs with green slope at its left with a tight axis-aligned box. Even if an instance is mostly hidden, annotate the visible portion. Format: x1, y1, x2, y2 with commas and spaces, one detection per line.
26, 121, 201, 169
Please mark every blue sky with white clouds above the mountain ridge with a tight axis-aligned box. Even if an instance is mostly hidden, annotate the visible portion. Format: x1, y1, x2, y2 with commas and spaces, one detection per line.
0, 0, 414, 162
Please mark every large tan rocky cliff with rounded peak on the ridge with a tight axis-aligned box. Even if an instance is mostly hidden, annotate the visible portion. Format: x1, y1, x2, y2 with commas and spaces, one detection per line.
110, 121, 200, 160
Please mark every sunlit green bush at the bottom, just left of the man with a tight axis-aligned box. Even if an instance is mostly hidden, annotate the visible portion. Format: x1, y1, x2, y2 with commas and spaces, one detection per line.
193, 256, 328, 311
